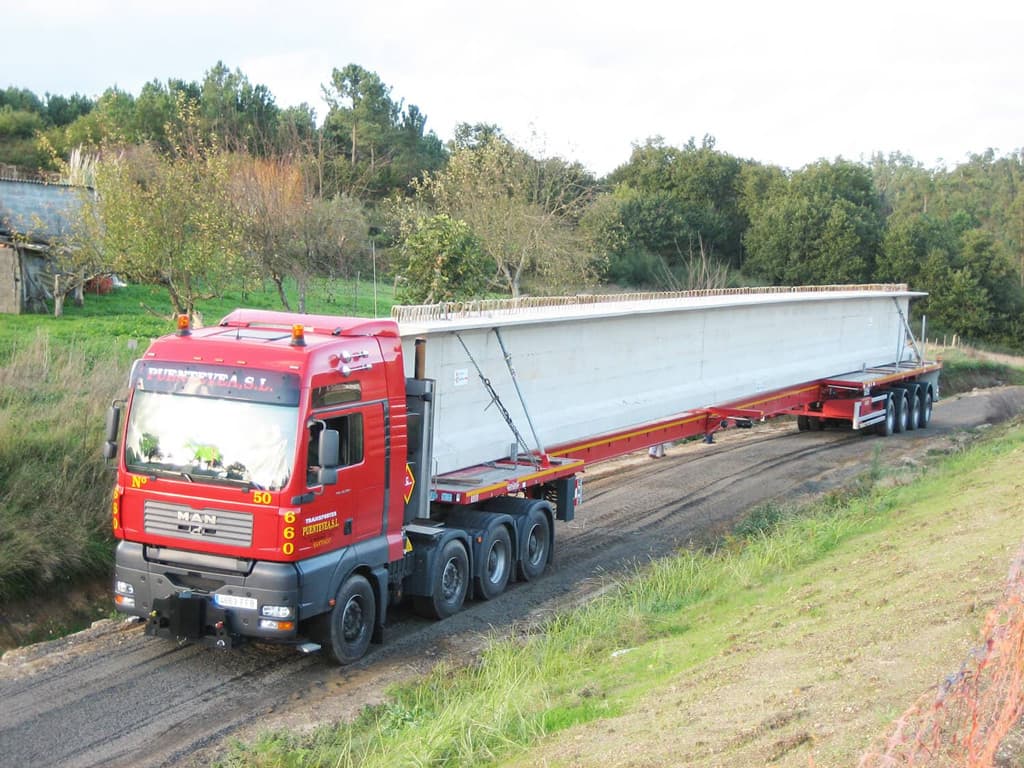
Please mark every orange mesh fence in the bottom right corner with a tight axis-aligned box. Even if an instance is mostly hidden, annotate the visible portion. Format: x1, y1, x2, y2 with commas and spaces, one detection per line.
858, 546, 1024, 768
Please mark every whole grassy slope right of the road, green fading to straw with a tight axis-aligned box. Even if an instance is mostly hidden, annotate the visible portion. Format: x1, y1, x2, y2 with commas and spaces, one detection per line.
228, 417, 1024, 767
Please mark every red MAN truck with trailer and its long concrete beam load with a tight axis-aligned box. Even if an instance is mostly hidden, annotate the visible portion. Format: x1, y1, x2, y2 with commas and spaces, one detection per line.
104, 286, 940, 664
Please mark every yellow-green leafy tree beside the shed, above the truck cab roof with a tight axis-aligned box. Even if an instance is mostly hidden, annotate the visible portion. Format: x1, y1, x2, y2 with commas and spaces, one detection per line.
86, 96, 243, 316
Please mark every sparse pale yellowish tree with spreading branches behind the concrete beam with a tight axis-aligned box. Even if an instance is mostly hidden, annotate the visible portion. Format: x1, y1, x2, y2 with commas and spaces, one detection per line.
413, 136, 597, 296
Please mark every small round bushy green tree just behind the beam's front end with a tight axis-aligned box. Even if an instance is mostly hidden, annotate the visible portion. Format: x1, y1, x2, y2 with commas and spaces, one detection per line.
397, 214, 494, 304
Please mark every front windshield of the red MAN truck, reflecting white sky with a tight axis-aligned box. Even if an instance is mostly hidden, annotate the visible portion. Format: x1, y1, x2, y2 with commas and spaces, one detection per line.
125, 390, 299, 490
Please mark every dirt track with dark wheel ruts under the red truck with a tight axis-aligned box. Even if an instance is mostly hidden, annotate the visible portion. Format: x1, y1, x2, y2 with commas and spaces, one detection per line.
0, 388, 1024, 766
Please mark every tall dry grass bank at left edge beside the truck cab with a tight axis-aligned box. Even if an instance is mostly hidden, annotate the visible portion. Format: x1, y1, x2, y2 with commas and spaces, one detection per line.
0, 332, 132, 602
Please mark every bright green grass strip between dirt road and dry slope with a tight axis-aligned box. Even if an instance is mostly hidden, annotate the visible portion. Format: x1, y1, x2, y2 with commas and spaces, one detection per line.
224, 424, 1024, 768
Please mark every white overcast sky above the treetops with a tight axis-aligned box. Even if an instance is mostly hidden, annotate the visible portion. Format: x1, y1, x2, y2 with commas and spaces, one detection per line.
0, 0, 1024, 175
